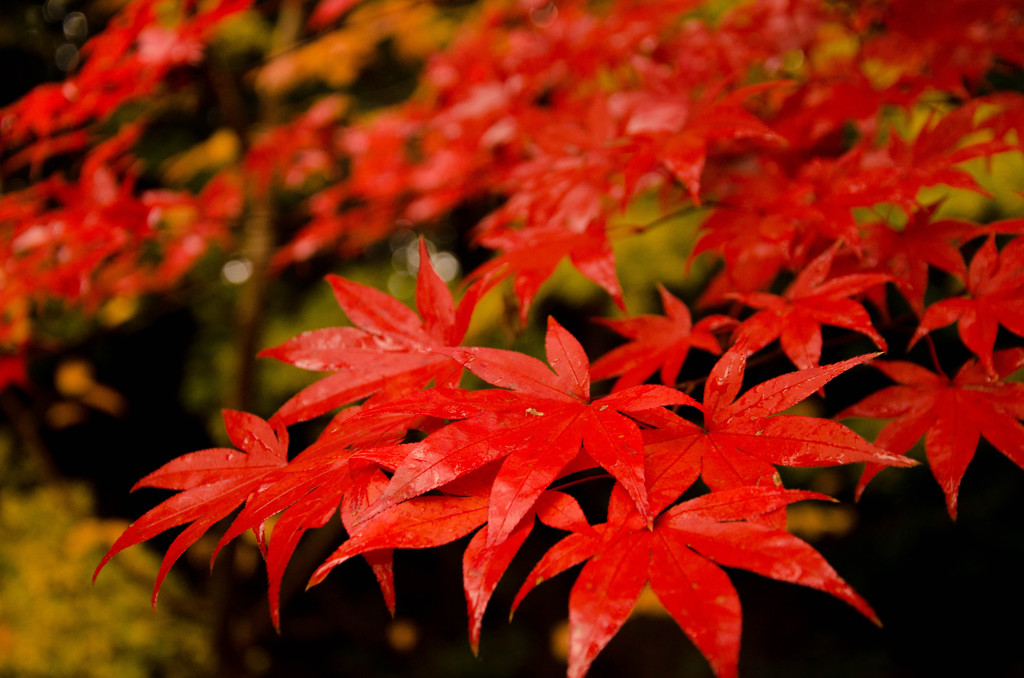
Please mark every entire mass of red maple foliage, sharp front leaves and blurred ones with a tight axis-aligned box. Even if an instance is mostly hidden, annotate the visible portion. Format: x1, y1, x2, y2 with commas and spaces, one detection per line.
0, 0, 1024, 678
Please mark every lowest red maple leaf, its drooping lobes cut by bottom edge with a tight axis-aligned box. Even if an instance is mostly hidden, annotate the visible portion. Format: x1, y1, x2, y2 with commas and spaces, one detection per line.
513, 484, 879, 678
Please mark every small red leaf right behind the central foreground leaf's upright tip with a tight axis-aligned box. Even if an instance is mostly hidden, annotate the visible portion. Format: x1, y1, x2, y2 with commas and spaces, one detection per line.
591, 285, 735, 390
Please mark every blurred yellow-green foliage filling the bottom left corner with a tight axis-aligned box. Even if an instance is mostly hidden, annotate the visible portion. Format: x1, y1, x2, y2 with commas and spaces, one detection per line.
0, 483, 212, 678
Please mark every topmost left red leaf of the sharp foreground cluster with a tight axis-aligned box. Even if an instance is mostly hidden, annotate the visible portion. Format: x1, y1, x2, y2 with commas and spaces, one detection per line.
260, 236, 481, 424
